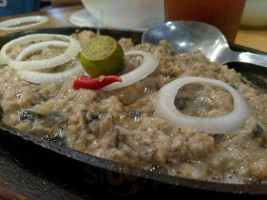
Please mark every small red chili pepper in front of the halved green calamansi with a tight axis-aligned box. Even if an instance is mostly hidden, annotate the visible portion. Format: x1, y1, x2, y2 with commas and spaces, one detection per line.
72, 75, 122, 90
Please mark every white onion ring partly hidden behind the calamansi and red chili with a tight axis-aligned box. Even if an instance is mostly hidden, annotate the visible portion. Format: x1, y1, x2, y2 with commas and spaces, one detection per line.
101, 51, 159, 91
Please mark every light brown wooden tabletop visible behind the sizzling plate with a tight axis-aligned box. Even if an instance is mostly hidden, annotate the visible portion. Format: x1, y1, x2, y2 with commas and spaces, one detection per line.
0, 5, 267, 53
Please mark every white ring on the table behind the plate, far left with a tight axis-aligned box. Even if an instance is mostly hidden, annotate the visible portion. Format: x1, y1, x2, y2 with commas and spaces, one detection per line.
0, 15, 48, 31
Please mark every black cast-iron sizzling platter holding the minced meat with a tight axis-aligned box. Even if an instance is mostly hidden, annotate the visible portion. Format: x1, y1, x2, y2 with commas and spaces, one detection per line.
0, 27, 267, 197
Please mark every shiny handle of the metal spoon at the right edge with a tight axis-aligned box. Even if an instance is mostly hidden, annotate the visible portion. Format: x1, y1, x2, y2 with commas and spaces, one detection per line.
224, 50, 267, 68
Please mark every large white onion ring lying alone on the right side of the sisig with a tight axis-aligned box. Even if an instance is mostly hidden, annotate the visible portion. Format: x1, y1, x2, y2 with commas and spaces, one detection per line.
155, 77, 250, 133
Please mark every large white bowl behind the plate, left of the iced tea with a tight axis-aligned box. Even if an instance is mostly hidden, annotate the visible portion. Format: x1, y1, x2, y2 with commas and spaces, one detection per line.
82, 0, 164, 29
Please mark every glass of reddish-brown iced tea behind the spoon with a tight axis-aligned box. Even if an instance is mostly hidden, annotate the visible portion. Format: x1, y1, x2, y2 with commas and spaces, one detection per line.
164, 0, 245, 42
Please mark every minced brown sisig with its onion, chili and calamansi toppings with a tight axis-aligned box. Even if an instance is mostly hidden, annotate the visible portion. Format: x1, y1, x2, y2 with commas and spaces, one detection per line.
0, 31, 267, 184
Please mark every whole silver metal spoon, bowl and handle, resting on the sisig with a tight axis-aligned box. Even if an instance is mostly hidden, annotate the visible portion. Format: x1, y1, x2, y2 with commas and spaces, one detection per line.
142, 21, 267, 67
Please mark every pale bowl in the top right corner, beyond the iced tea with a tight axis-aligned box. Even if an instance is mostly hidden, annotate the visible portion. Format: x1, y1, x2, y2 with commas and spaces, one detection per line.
241, 0, 267, 28
